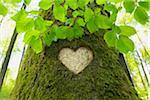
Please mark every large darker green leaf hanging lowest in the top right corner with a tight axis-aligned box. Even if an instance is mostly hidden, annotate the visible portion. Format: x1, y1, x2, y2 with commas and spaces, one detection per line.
134, 7, 149, 25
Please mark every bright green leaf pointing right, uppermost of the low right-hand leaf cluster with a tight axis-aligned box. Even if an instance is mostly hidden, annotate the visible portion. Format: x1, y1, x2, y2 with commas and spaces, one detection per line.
120, 26, 136, 36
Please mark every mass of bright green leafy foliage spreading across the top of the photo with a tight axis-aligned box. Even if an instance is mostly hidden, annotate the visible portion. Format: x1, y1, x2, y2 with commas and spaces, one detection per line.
0, 0, 150, 53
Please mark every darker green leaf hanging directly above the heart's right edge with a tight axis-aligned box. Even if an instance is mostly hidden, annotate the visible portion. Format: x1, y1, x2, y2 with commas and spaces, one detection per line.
87, 18, 98, 33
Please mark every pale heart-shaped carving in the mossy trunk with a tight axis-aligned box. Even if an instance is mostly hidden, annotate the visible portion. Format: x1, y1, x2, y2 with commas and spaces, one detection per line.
59, 47, 93, 74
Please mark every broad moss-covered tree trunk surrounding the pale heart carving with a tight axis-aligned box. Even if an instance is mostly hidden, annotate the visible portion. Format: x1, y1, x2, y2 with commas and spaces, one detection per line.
10, 33, 139, 100
